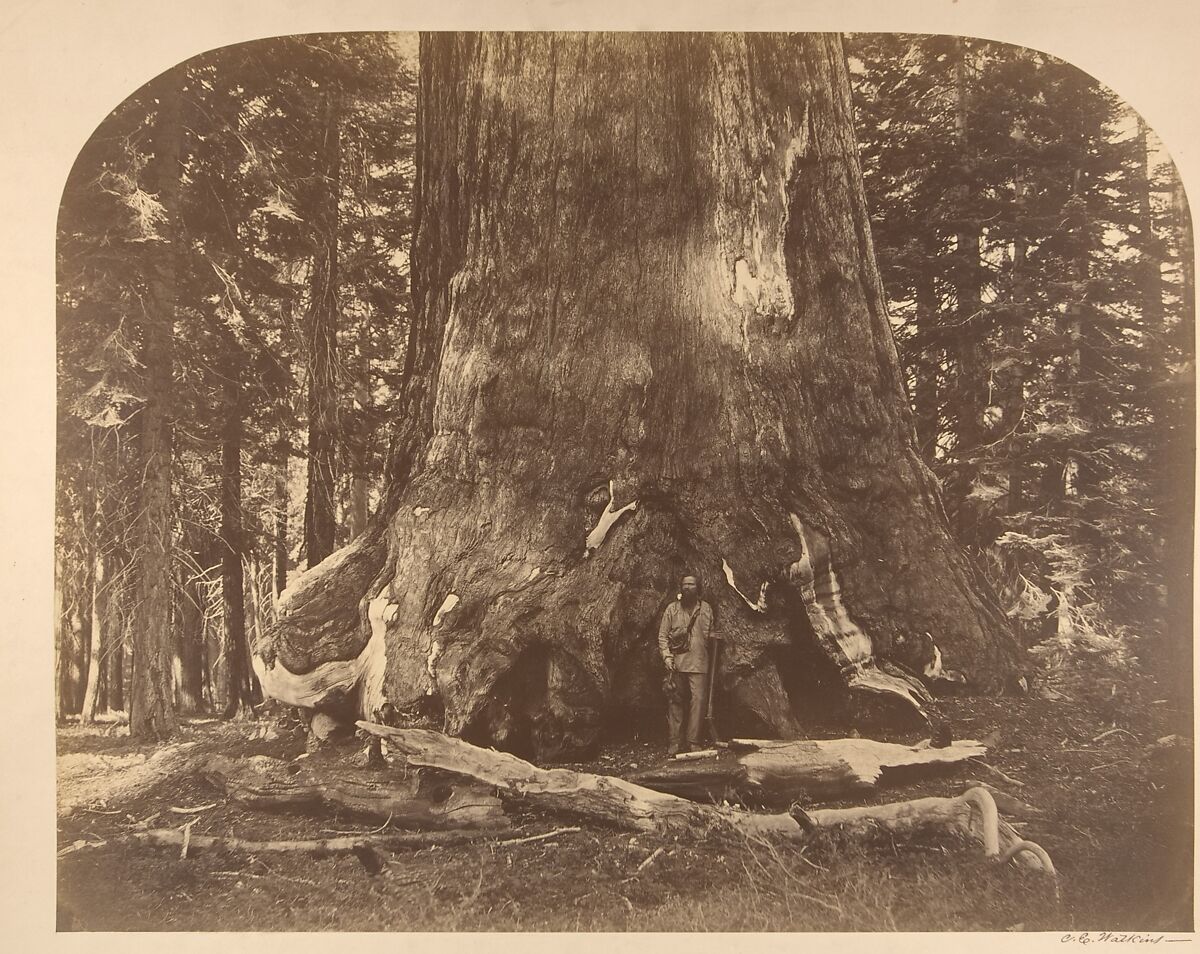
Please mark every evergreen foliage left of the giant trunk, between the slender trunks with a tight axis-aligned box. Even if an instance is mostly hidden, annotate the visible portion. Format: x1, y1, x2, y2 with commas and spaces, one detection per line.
56, 34, 414, 729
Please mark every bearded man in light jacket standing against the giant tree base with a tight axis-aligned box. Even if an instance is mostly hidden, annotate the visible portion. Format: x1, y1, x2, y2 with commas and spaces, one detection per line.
659, 575, 718, 756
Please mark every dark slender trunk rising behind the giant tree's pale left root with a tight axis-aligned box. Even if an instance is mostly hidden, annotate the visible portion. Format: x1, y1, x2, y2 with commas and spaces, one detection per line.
305, 92, 342, 568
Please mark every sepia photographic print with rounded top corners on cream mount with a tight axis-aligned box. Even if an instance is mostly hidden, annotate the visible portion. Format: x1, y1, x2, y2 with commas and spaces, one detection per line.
55, 32, 1194, 940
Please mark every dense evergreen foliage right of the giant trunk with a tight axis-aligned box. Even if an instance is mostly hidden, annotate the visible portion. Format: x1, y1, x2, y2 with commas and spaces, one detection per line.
850, 35, 1194, 691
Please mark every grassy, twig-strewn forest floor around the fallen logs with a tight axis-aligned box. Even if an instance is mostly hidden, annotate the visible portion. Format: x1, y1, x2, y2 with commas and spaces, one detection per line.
58, 697, 1193, 932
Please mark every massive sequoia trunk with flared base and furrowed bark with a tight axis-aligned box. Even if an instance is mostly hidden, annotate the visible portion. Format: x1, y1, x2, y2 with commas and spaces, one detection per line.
256, 34, 1015, 757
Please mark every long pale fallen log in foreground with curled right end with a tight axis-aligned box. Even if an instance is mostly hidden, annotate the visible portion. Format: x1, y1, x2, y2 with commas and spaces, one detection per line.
358, 722, 1049, 862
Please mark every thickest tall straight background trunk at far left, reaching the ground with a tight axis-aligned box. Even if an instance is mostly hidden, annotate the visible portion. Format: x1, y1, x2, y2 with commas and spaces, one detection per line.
130, 67, 182, 740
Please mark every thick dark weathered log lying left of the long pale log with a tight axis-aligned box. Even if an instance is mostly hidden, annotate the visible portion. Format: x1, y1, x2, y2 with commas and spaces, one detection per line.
200, 755, 509, 829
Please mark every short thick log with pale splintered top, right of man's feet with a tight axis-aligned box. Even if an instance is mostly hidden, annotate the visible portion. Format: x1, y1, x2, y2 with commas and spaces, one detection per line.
634, 739, 988, 804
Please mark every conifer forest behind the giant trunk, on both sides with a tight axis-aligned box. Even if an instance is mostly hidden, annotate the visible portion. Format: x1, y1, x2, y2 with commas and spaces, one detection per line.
55, 34, 1194, 736
